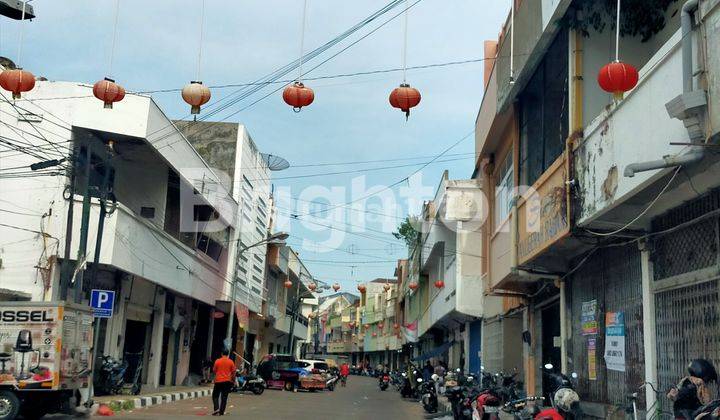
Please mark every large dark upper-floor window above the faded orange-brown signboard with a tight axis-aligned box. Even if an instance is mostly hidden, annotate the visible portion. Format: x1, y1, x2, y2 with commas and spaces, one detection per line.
519, 31, 568, 186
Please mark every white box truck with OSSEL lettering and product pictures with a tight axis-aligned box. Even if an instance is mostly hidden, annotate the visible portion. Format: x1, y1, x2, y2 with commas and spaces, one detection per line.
0, 302, 93, 420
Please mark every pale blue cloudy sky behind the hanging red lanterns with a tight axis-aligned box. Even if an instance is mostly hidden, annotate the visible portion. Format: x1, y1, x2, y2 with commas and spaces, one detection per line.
0, 0, 509, 291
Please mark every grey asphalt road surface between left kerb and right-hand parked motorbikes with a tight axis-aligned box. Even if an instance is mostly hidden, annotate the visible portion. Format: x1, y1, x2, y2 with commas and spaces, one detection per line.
115, 376, 424, 420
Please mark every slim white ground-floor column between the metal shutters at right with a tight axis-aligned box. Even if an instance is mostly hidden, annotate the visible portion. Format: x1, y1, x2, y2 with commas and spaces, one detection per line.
638, 241, 658, 407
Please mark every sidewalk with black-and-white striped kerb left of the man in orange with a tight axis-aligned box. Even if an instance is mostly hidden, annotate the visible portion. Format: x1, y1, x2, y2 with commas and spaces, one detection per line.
94, 385, 212, 412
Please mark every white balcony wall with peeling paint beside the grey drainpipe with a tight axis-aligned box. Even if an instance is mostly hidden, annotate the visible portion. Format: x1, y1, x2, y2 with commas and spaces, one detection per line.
575, 32, 688, 227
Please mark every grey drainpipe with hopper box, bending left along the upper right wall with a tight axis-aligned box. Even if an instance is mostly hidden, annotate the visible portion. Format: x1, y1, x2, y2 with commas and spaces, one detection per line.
624, 0, 707, 178
